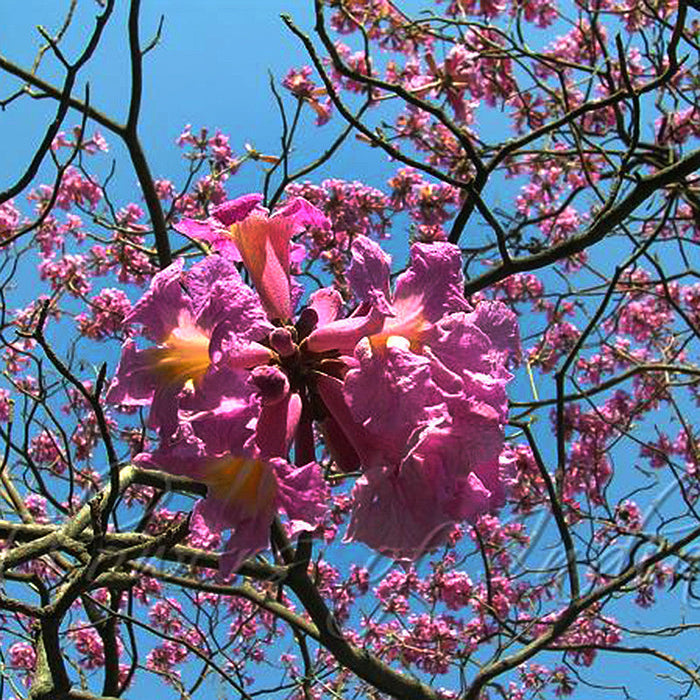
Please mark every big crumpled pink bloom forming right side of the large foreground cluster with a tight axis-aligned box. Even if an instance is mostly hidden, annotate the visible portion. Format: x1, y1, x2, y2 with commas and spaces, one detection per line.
309, 239, 519, 559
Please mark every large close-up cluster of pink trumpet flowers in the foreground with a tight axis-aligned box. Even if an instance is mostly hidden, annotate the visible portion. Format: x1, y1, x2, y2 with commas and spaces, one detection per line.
108, 195, 519, 574
